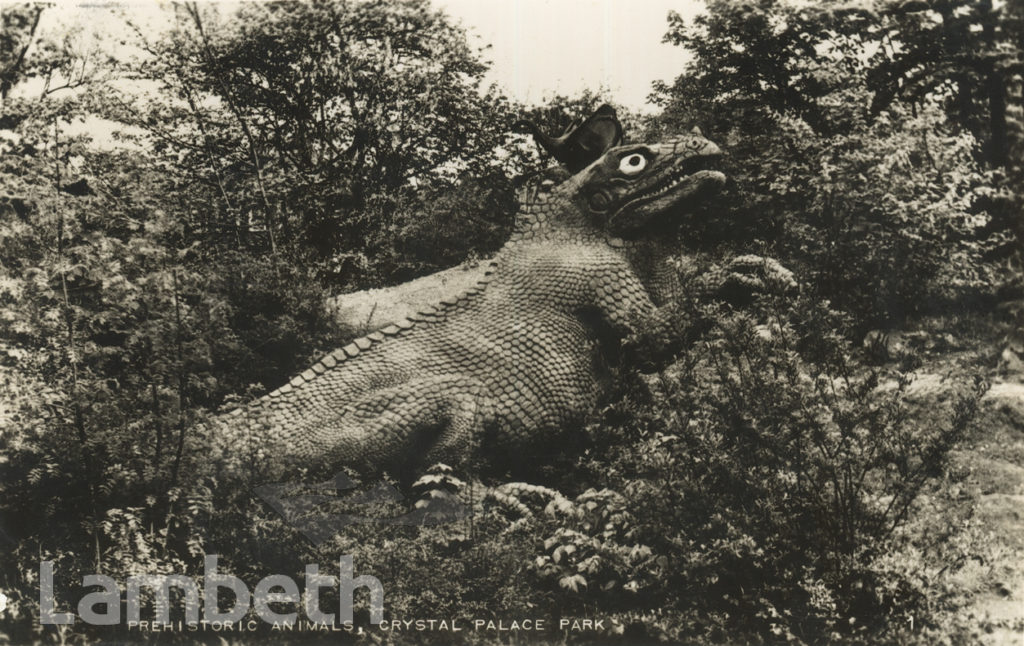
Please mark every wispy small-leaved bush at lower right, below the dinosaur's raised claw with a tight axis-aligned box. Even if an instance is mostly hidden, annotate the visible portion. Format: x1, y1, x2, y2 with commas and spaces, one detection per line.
598, 296, 980, 643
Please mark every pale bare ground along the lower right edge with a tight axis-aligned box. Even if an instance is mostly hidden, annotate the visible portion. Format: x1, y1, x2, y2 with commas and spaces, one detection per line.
908, 315, 1024, 646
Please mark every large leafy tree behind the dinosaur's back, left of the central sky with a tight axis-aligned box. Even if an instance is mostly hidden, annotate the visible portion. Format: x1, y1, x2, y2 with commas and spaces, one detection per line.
119, 0, 528, 282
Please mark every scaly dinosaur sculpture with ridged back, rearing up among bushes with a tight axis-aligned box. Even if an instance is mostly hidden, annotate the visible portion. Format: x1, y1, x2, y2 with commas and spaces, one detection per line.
210, 135, 725, 479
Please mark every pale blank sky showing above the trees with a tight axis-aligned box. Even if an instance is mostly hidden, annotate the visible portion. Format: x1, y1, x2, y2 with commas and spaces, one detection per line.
32, 0, 702, 112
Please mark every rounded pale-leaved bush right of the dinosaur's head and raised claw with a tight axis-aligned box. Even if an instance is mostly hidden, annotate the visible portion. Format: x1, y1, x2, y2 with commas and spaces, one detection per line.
764, 102, 995, 333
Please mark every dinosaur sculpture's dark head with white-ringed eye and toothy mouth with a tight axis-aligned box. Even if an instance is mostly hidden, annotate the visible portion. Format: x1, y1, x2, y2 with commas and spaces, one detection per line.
566, 129, 725, 238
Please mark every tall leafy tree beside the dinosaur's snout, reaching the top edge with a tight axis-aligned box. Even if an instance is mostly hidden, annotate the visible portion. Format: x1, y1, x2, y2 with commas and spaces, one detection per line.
654, 0, 997, 332
